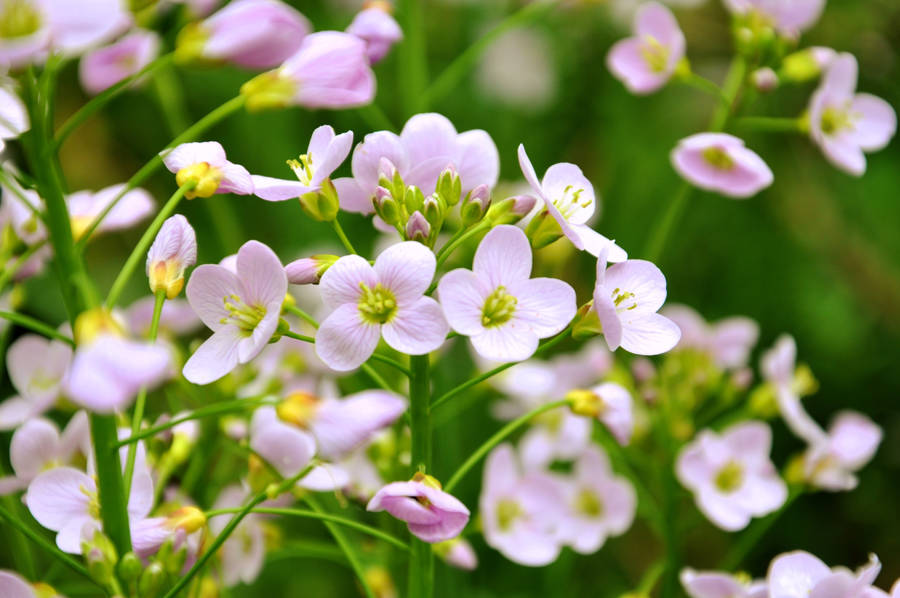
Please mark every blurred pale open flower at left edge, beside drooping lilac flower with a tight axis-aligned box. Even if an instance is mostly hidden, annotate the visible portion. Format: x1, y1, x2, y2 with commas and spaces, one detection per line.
0, 334, 72, 430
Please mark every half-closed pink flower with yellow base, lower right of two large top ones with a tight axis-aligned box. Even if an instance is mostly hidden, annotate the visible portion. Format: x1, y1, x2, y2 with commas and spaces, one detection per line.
241, 31, 375, 110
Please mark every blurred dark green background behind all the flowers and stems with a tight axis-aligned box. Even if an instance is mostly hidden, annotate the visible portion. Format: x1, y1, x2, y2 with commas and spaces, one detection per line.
7, 0, 900, 598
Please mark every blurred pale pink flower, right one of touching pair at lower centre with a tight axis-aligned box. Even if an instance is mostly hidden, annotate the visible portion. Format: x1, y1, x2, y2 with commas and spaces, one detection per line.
560, 447, 637, 554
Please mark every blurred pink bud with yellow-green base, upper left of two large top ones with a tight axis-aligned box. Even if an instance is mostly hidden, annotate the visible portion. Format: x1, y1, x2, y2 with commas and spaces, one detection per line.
175, 0, 312, 69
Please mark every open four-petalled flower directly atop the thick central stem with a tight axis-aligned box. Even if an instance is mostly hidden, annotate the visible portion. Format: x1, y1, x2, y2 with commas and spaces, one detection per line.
316, 241, 449, 371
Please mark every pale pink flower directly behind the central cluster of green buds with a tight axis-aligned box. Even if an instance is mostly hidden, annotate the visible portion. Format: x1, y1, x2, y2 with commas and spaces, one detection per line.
334, 113, 500, 214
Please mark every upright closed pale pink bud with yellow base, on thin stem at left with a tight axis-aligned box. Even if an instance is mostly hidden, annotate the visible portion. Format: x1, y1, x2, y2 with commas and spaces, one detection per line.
147, 214, 197, 299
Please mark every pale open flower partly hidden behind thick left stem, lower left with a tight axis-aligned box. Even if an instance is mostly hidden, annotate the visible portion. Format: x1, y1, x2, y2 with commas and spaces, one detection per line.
25, 459, 153, 554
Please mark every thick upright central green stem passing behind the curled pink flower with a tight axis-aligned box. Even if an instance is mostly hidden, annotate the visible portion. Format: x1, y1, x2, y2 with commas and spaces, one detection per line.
407, 355, 434, 598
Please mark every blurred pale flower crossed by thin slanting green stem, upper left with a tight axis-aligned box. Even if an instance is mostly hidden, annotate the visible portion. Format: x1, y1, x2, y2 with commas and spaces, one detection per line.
66, 183, 156, 239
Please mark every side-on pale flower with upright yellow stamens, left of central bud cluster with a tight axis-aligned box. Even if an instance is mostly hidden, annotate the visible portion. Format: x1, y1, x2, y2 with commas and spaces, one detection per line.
253, 125, 353, 201
